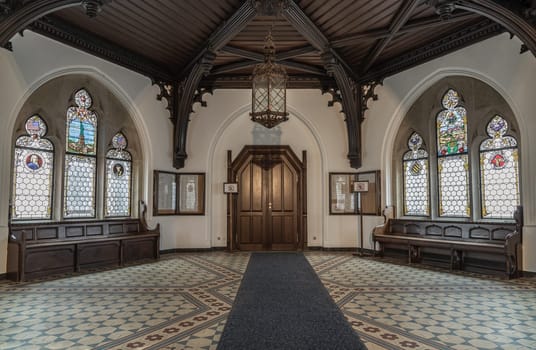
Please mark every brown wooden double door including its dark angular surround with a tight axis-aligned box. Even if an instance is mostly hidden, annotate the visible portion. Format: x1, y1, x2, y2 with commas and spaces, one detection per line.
228, 146, 307, 250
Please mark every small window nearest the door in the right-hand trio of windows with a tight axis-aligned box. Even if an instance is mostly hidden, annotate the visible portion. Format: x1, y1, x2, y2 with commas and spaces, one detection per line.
403, 132, 430, 216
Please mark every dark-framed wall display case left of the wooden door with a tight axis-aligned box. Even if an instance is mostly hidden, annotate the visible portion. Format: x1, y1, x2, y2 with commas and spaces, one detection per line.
153, 170, 205, 216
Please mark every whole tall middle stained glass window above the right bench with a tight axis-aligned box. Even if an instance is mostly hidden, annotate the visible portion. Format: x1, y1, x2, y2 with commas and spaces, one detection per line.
436, 89, 471, 217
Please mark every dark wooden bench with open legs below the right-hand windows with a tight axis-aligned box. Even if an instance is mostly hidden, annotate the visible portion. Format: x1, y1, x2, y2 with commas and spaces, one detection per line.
372, 207, 523, 278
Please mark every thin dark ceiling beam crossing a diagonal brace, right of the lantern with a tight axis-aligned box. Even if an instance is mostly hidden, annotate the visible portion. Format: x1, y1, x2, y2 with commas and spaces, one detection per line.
331, 12, 476, 48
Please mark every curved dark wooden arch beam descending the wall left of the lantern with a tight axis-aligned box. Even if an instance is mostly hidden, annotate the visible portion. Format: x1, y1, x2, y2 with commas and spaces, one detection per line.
173, 0, 257, 169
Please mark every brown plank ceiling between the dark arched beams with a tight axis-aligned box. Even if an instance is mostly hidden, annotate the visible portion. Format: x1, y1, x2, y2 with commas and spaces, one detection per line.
30, 0, 504, 87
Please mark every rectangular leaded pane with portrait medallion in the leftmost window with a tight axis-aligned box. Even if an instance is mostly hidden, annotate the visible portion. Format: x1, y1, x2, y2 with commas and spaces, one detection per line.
12, 147, 54, 220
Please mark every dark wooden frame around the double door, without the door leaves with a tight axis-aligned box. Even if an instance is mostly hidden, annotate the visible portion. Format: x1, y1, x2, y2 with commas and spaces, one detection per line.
227, 145, 307, 251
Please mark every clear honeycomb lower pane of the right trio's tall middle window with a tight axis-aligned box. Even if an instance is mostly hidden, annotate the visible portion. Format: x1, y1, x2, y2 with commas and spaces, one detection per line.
437, 154, 471, 217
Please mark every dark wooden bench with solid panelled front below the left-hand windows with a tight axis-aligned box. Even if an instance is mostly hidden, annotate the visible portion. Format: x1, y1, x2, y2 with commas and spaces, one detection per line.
7, 204, 160, 282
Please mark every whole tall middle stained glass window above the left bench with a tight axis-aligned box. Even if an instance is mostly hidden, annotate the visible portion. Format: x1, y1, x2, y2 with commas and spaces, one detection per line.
63, 89, 97, 218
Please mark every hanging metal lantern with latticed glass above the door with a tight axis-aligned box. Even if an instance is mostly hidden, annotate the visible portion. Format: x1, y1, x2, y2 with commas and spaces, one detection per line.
249, 33, 288, 129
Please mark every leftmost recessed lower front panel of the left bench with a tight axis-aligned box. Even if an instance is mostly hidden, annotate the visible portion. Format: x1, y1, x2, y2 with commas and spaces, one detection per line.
24, 244, 76, 278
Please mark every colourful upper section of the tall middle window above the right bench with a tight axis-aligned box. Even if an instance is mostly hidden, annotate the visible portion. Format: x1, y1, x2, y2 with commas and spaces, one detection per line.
437, 89, 467, 156
